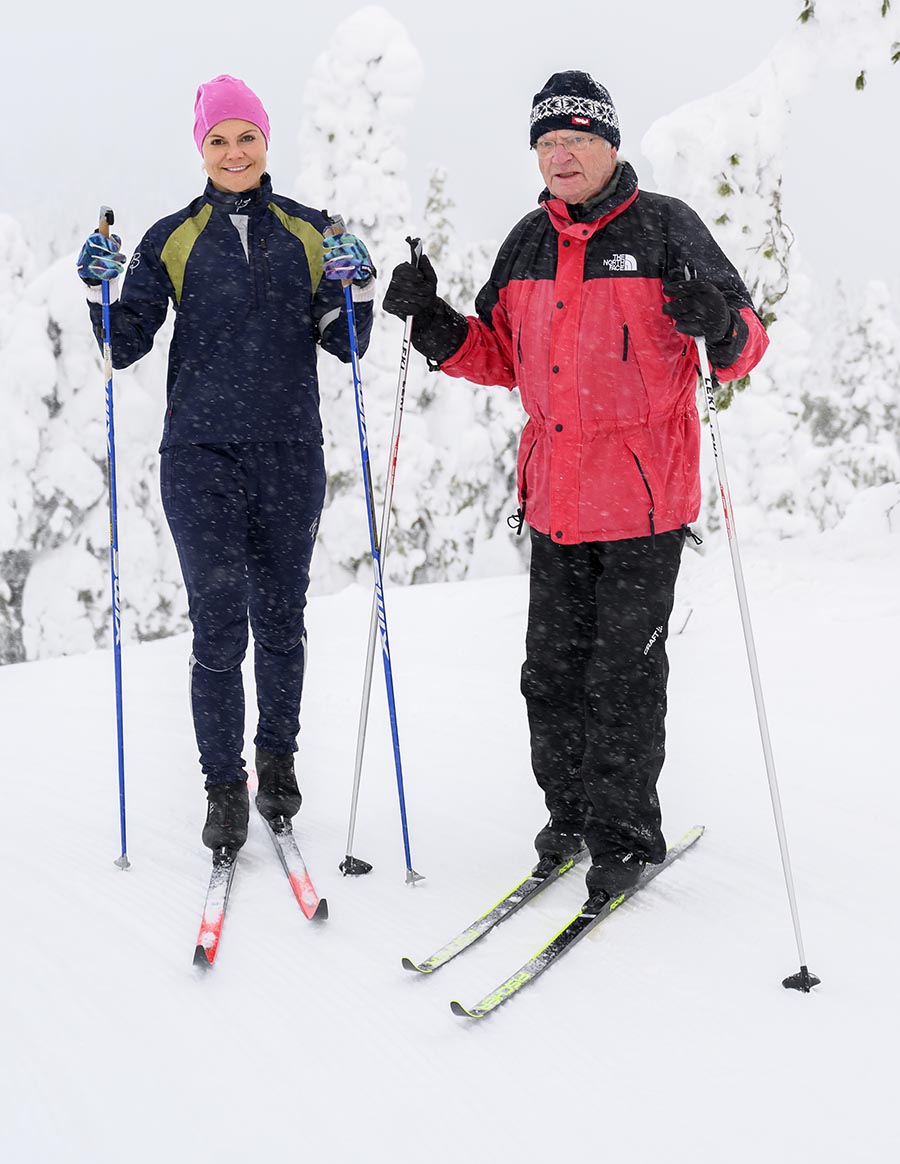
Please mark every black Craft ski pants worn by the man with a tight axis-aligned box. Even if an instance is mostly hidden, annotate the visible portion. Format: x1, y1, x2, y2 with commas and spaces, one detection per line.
522, 528, 686, 863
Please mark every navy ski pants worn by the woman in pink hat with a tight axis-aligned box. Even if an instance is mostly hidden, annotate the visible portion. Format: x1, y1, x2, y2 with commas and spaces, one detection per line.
160, 441, 325, 788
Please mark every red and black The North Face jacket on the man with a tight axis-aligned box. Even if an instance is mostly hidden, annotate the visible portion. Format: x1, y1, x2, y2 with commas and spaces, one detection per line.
440, 163, 768, 545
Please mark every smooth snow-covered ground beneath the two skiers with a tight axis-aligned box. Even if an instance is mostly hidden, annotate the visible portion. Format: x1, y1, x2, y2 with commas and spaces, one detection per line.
0, 487, 900, 1164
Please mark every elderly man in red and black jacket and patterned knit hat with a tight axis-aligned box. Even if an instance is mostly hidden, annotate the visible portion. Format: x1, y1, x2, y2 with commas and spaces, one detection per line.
384, 71, 767, 904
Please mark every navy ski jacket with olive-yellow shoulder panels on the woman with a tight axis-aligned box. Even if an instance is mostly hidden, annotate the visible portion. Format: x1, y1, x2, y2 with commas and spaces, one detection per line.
90, 175, 373, 450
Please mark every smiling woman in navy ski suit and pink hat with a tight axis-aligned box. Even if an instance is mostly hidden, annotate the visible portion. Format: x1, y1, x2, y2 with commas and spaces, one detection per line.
78, 76, 374, 851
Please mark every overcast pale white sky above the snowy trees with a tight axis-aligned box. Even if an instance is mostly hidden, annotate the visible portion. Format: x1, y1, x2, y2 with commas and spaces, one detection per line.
0, 0, 900, 300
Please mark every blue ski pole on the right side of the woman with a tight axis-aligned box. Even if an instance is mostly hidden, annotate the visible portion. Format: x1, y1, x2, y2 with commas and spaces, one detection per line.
326, 215, 423, 885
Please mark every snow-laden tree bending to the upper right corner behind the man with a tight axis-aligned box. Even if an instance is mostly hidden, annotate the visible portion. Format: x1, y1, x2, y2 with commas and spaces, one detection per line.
642, 0, 900, 535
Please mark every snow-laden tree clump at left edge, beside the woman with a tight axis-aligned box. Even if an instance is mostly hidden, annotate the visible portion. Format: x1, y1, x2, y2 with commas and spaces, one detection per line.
0, 238, 184, 661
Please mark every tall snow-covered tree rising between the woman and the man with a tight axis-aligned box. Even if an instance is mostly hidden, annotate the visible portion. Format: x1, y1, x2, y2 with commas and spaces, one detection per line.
295, 6, 421, 590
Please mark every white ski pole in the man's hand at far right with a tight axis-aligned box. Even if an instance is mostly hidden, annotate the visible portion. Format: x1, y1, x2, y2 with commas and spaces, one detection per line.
688, 314, 821, 994
